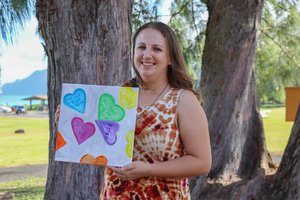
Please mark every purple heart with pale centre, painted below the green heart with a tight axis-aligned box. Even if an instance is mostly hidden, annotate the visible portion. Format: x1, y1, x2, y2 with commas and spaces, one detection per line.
96, 120, 119, 145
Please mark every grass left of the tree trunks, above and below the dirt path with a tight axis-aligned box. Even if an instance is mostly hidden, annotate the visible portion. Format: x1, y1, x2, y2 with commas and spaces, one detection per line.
0, 116, 49, 200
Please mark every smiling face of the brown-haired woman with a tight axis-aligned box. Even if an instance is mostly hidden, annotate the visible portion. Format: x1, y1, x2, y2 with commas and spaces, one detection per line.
134, 28, 171, 82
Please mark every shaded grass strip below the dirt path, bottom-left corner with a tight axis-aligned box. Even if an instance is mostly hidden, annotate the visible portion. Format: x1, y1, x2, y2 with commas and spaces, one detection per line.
0, 178, 46, 200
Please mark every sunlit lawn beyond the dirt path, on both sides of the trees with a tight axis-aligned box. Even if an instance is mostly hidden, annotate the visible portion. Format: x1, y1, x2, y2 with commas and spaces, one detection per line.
0, 107, 293, 167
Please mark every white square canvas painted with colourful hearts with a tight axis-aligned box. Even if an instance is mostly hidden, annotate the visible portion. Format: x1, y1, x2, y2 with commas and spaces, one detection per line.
55, 83, 138, 167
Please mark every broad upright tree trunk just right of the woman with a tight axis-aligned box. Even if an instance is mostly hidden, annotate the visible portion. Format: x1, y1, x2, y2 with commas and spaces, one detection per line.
190, 0, 274, 199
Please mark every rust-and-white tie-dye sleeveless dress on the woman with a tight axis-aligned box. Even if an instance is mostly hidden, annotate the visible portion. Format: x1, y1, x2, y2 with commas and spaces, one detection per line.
102, 88, 190, 200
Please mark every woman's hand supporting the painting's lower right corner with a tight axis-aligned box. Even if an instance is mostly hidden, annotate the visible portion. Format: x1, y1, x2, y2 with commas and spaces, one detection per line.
108, 161, 151, 180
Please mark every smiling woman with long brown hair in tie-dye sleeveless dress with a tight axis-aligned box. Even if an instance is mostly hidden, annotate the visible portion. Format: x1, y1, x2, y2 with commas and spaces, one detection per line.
103, 22, 211, 199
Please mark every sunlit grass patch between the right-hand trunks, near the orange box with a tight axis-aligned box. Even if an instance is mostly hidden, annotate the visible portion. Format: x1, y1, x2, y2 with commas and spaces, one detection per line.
261, 107, 293, 155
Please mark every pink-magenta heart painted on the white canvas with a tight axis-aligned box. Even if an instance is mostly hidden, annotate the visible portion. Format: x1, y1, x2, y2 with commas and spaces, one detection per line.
71, 117, 96, 144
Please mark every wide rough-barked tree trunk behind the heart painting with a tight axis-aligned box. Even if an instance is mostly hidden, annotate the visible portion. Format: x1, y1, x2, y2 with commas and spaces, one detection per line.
36, 0, 131, 200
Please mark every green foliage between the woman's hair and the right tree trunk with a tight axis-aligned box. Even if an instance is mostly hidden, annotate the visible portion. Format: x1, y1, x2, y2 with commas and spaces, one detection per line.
169, 0, 207, 86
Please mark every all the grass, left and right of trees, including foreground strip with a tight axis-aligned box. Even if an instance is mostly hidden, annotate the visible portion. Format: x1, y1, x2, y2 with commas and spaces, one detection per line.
0, 107, 293, 200
